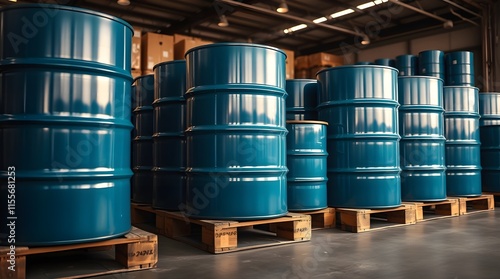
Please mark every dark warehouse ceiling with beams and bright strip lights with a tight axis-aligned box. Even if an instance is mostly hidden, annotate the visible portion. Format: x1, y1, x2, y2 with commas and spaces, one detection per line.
0, 0, 484, 54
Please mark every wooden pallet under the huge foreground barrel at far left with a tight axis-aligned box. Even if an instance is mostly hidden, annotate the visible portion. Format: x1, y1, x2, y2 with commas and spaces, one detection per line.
0, 227, 158, 279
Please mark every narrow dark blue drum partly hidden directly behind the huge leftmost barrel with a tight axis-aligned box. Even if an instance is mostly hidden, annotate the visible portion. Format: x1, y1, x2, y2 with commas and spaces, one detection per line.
132, 75, 155, 204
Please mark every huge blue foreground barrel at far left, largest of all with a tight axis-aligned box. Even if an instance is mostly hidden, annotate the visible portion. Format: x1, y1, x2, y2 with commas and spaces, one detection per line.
0, 4, 133, 246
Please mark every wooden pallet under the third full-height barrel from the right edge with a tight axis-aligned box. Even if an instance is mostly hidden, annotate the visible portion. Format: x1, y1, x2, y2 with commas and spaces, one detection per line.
404, 199, 460, 222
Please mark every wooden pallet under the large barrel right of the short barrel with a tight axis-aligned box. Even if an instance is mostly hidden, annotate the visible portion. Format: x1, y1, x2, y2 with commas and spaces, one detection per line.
335, 204, 416, 233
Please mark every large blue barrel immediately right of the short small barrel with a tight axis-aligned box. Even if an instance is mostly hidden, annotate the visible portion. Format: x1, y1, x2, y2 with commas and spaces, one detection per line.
317, 65, 401, 208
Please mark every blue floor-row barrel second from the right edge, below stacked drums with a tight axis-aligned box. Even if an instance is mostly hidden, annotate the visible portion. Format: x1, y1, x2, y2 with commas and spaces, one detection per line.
443, 86, 481, 197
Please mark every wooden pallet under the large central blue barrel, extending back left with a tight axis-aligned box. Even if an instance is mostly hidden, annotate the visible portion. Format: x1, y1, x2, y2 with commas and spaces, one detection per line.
132, 204, 311, 254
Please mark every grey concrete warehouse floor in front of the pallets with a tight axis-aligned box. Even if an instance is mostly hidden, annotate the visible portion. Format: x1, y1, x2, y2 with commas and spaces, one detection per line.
28, 212, 500, 279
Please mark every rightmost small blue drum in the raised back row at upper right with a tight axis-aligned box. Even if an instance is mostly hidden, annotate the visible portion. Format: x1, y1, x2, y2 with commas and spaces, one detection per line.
444, 51, 474, 86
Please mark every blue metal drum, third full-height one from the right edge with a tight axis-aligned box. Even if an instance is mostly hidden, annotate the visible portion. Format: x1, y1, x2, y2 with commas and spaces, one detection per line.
398, 76, 446, 201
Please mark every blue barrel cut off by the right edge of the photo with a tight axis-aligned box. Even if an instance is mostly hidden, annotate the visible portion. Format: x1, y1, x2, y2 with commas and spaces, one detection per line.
479, 92, 500, 193
